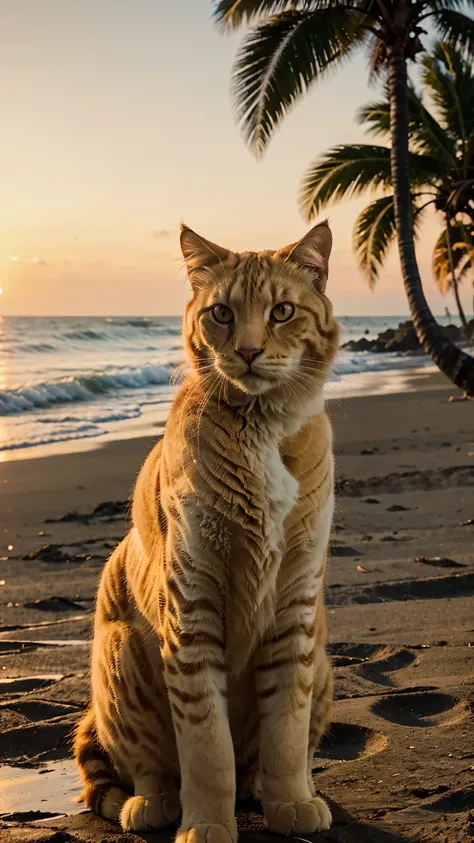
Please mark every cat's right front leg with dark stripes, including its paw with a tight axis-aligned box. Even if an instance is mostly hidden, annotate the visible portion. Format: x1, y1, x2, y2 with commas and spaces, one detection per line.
256, 593, 331, 835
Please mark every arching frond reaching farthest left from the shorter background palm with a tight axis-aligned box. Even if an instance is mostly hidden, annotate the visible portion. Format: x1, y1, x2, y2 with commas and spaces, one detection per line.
299, 144, 437, 221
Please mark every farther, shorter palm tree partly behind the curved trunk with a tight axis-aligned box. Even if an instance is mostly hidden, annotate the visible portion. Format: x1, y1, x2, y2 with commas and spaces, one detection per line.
301, 43, 474, 332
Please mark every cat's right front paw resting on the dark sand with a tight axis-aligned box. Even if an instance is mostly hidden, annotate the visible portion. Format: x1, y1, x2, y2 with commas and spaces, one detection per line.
264, 796, 332, 835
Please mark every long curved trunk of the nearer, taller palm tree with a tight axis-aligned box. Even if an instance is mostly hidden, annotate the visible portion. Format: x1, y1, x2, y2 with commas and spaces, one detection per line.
389, 37, 474, 396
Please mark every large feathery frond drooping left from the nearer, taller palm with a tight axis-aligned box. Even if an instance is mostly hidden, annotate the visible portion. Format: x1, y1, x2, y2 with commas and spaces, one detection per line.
232, 5, 362, 155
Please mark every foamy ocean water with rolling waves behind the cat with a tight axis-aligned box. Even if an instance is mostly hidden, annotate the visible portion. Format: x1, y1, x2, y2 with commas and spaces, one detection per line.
0, 316, 460, 461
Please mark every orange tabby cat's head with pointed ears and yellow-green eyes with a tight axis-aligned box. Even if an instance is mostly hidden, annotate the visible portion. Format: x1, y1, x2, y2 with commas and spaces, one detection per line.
181, 223, 338, 398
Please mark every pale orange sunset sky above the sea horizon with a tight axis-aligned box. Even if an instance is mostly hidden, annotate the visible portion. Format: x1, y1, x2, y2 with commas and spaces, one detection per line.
0, 0, 471, 315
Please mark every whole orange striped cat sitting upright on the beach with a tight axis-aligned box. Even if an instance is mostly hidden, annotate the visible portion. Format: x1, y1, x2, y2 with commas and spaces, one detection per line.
75, 224, 338, 843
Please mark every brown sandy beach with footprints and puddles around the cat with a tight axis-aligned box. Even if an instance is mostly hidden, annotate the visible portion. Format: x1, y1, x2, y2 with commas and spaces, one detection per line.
0, 374, 474, 843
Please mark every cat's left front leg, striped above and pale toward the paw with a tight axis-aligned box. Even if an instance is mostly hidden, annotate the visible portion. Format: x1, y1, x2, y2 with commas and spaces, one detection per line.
163, 562, 237, 843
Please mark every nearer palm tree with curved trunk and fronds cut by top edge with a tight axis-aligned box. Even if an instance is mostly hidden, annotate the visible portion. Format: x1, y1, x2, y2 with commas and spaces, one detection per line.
212, 0, 474, 395
